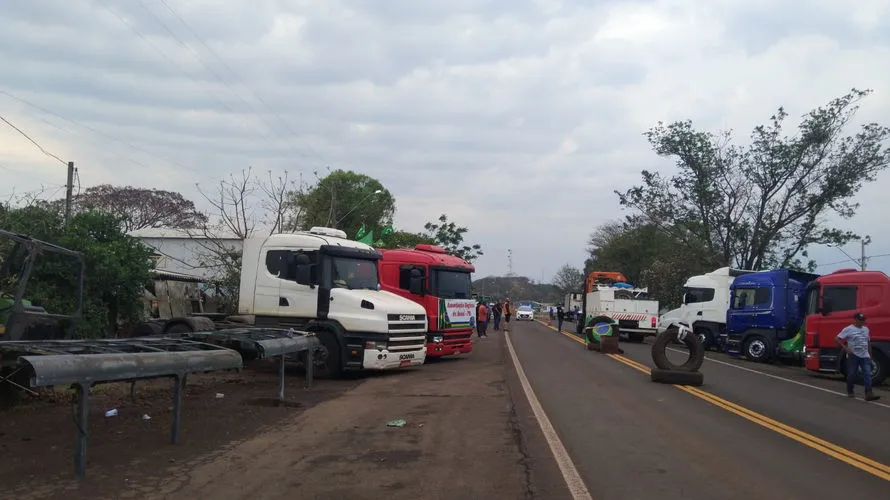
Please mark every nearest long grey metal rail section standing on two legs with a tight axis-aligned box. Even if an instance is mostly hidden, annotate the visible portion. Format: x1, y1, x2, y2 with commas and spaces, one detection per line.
0, 337, 243, 479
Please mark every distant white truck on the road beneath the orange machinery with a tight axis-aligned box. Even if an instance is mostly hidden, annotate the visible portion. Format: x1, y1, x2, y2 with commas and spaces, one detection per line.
584, 285, 658, 342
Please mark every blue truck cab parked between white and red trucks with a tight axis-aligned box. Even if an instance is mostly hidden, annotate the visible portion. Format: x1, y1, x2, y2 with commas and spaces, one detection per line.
726, 269, 819, 363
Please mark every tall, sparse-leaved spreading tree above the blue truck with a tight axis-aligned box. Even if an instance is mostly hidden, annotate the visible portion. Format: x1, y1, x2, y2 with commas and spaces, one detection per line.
616, 89, 890, 270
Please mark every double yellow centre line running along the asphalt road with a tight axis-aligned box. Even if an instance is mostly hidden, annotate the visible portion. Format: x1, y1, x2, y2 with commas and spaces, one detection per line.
542, 323, 890, 481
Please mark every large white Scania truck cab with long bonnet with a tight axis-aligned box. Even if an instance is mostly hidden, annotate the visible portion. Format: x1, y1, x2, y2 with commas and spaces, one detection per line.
238, 227, 427, 377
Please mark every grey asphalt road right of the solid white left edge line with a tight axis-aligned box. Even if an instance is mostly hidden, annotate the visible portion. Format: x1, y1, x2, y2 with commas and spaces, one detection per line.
502, 323, 890, 500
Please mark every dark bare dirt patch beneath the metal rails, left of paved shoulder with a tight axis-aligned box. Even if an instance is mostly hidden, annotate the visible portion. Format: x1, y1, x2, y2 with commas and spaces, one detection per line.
0, 362, 361, 499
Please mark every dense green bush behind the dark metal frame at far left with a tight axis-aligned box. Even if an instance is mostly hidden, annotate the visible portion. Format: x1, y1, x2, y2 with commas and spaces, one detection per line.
0, 206, 152, 337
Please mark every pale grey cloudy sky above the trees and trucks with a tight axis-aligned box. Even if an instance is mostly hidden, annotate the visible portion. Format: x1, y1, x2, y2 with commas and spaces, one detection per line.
0, 0, 890, 280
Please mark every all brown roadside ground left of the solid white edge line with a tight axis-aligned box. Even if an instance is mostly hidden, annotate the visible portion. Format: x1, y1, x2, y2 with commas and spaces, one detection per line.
0, 335, 534, 500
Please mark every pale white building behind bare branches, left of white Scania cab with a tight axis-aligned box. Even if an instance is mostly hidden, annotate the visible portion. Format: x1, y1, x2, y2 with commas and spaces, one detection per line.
130, 228, 243, 279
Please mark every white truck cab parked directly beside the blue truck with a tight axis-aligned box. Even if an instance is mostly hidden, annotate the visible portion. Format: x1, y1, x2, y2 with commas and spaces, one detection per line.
658, 267, 755, 349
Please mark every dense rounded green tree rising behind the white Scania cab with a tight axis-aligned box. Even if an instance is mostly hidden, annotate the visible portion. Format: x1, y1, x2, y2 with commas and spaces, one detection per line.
289, 170, 395, 238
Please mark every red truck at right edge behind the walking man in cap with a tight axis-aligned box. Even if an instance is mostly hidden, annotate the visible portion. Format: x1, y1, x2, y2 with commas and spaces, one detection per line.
805, 269, 890, 385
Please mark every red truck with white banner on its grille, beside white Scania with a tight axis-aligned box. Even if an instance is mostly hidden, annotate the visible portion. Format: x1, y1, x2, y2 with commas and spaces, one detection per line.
377, 245, 476, 357
